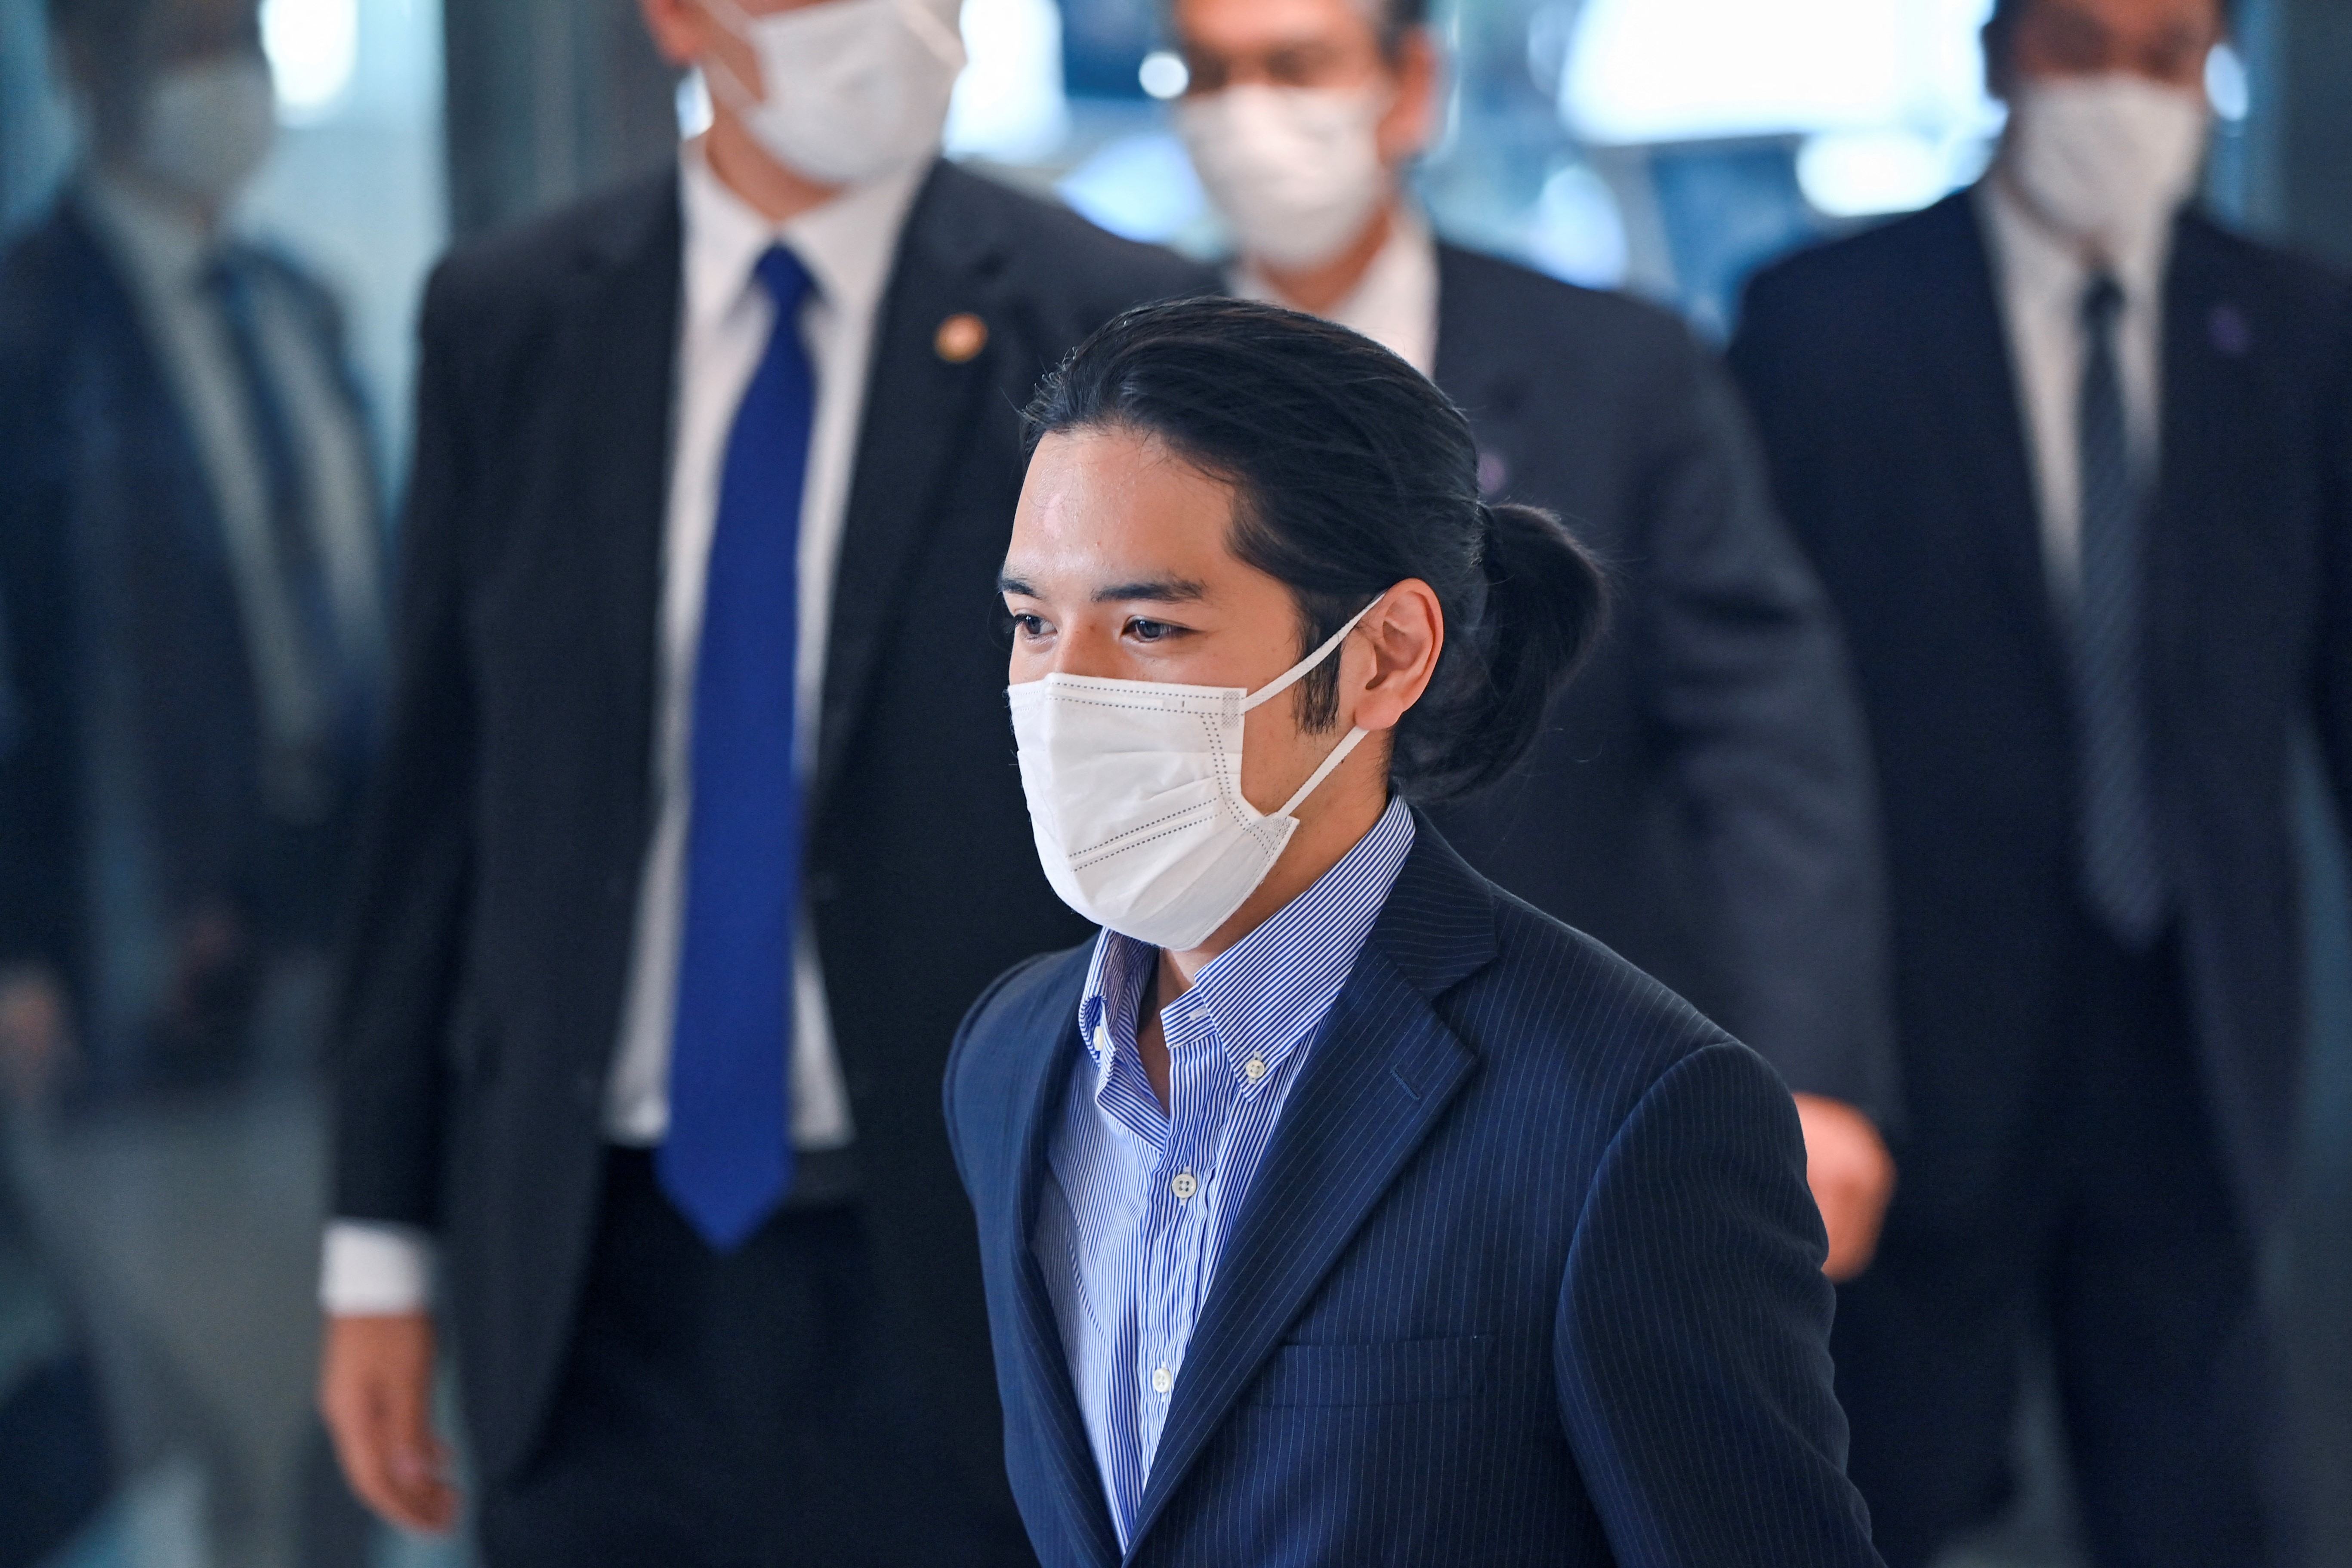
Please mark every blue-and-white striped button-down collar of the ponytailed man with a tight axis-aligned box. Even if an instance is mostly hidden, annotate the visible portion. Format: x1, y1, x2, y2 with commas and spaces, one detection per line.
1077, 799, 1414, 1096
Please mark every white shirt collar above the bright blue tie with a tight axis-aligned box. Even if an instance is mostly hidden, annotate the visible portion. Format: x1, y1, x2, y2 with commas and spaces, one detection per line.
677, 136, 932, 322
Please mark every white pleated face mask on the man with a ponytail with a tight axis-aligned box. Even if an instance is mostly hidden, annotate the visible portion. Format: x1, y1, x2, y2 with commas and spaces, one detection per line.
1009, 599, 1378, 952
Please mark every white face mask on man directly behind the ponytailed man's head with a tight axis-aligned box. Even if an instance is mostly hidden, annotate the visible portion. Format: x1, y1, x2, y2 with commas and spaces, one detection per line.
1176, 87, 1390, 268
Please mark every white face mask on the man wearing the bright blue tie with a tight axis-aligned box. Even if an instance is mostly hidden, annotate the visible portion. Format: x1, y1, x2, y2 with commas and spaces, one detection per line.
703, 0, 964, 186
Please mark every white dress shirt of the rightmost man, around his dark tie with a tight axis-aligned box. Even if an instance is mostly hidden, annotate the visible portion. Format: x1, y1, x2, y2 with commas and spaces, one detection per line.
1975, 176, 2173, 607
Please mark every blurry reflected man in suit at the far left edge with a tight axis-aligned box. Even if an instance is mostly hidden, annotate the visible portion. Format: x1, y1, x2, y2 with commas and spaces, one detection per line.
0, 0, 386, 1563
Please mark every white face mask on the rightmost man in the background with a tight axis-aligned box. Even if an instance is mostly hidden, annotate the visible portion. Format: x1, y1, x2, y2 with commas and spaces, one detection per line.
2002, 73, 2206, 259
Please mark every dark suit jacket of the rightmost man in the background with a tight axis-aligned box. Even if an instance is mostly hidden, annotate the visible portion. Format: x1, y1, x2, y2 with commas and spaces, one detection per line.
1731, 195, 2352, 1227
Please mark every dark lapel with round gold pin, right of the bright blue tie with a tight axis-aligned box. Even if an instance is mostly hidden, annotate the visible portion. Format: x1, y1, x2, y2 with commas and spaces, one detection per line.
809, 162, 1004, 821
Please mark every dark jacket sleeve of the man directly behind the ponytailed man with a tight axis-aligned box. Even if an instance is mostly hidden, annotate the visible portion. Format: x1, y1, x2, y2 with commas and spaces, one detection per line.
1630, 352, 1898, 1124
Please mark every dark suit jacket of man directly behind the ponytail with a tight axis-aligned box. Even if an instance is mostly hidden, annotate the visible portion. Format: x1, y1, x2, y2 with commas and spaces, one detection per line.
1437, 247, 1896, 1119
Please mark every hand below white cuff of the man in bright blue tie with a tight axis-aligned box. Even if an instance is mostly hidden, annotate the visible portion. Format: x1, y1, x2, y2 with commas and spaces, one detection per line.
318, 1312, 456, 1535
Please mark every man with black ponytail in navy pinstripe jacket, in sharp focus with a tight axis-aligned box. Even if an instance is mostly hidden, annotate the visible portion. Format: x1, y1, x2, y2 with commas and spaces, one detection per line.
945, 301, 1879, 1568
